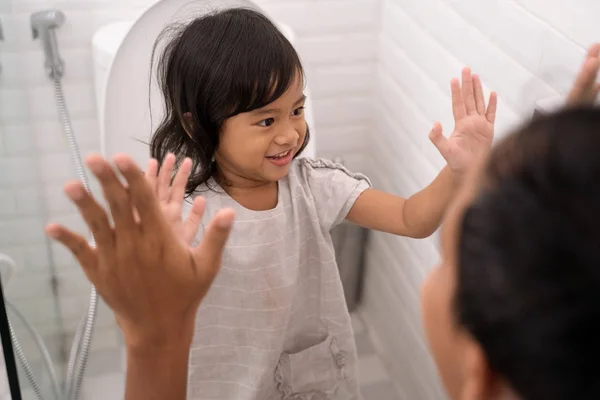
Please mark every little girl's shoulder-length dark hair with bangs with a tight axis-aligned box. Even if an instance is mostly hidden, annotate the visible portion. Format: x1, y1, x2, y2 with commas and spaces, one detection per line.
150, 8, 310, 195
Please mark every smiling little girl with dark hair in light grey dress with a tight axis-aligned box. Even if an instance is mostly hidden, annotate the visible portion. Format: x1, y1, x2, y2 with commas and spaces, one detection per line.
143, 9, 496, 400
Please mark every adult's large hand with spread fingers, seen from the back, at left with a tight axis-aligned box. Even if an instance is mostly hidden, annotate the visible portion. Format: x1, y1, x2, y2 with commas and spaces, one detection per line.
47, 155, 234, 349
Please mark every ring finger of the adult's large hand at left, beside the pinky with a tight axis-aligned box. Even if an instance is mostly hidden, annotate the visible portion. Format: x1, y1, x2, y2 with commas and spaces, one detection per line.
65, 181, 114, 246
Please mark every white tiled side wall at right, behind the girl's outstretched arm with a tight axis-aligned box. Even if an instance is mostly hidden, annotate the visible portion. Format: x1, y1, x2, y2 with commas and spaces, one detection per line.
363, 0, 600, 400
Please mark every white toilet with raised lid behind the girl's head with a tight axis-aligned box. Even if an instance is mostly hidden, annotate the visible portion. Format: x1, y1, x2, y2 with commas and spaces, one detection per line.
92, 0, 316, 167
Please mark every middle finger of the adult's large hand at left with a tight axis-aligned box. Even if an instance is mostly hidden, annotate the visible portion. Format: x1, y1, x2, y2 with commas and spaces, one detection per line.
86, 155, 135, 232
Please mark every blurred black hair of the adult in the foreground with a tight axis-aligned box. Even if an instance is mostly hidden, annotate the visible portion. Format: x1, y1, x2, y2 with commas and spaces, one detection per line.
455, 109, 600, 400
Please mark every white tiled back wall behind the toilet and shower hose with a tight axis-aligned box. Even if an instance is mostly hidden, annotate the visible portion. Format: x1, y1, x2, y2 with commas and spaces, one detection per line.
0, 0, 380, 382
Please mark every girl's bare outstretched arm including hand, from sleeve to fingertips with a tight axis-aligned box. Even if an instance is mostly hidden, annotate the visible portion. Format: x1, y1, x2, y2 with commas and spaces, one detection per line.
346, 68, 497, 238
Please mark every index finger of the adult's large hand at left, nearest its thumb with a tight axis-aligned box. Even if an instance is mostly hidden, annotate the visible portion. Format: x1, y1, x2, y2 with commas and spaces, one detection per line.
113, 154, 164, 231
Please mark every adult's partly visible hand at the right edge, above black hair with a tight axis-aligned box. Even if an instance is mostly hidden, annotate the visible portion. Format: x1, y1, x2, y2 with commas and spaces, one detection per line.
567, 43, 600, 106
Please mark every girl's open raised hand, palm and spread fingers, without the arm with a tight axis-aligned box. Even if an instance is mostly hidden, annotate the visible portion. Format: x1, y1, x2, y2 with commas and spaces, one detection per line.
429, 68, 497, 176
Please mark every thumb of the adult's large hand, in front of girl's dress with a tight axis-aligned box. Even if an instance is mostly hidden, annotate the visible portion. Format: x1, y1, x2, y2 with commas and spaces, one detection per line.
194, 209, 235, 275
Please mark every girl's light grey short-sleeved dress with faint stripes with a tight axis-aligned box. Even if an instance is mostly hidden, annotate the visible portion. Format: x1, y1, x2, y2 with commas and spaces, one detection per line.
188, 159, 370, 400
